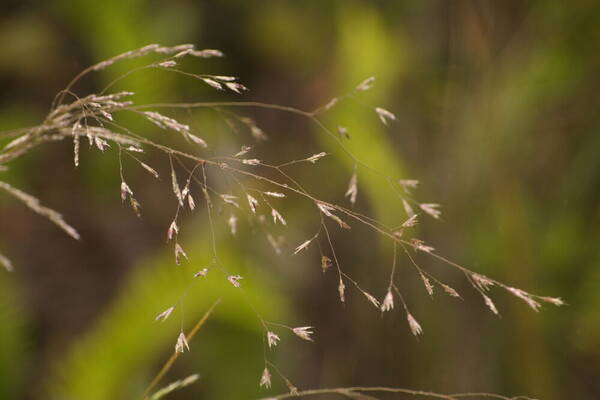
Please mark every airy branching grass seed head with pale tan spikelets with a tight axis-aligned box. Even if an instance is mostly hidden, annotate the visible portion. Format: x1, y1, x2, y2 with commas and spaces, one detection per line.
0, 44, 563, 400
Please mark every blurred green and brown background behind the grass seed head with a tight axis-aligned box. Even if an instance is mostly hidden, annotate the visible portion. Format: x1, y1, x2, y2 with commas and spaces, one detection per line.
0, 0, 600, 400
